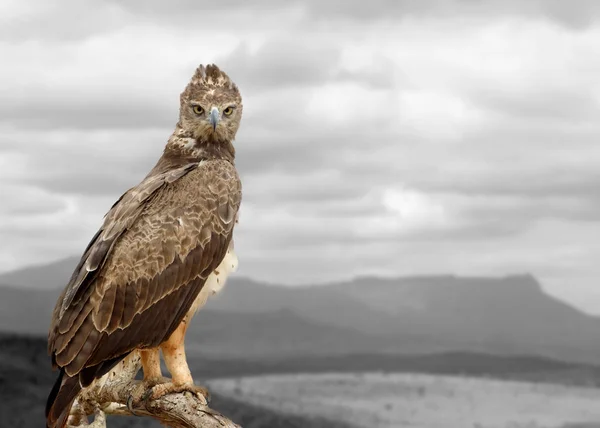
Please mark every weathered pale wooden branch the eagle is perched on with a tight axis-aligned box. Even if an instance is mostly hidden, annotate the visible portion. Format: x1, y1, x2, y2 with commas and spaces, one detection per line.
69, 352, 240, 428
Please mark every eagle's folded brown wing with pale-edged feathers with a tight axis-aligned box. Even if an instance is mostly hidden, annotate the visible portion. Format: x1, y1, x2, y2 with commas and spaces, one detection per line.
48, 160, 241, 376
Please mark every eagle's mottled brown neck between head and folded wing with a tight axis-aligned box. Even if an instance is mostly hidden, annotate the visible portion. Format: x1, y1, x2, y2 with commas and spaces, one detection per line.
149, 124, 235, 175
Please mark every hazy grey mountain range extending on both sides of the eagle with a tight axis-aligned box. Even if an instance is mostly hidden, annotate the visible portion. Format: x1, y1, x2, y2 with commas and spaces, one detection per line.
0, 259, 600, 364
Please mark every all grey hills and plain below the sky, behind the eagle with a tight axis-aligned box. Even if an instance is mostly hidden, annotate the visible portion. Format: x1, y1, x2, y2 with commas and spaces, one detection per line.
0, 259, 600, 428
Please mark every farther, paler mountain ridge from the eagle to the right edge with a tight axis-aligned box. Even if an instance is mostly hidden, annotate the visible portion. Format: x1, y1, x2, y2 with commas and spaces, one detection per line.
210, 275, 600, 362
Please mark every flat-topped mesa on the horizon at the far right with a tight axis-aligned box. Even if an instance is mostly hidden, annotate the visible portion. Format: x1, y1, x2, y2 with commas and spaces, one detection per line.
331, 274, 600, 362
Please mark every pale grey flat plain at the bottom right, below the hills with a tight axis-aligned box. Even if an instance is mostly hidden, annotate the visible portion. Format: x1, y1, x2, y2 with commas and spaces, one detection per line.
210, 372, 600, 428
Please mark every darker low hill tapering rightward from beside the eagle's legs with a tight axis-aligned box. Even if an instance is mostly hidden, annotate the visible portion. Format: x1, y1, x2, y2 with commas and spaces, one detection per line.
186, 309, 444, 360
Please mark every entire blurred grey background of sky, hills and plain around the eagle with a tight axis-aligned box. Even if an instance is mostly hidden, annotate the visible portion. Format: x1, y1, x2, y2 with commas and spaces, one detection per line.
0, 0, 600, 428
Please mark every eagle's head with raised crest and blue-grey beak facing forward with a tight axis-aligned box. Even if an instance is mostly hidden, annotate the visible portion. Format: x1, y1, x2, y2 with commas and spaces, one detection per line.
179, 64, 242, 142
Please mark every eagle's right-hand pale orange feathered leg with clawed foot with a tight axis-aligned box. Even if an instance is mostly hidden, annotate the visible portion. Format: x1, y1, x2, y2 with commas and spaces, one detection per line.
147, 320, 210, 402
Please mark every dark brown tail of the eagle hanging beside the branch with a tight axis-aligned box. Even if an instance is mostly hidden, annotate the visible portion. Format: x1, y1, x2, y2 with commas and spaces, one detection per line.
46, 369, 81, 428
